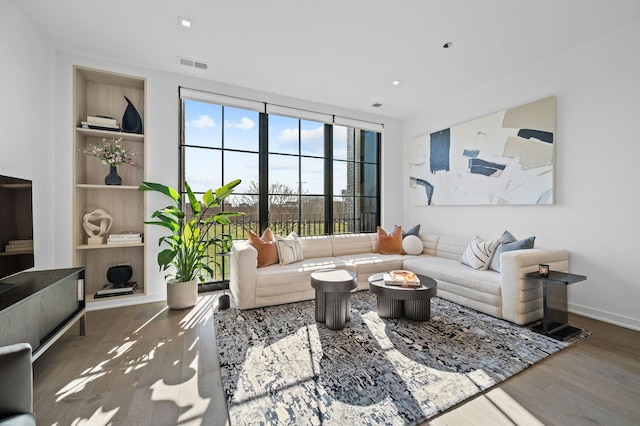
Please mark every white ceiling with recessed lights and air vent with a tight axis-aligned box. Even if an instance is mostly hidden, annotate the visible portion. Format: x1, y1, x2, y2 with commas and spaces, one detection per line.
17, 0, 640, 119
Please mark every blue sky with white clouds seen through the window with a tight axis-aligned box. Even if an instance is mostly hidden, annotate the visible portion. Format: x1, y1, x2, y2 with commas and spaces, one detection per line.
185, 100, 347, 195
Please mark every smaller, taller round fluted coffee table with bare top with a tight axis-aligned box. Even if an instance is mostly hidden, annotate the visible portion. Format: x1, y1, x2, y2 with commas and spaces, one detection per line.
311, 269, 357, 330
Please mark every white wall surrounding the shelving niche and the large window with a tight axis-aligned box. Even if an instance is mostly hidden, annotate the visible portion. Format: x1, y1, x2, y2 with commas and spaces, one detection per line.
55, 52, 403, 308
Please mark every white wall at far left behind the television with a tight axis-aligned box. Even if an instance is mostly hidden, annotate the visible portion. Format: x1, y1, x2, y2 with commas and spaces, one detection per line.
0, 0, 56, 269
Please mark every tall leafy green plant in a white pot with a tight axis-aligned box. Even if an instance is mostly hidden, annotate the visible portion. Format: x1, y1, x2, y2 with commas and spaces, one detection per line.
139, 179, 242, 309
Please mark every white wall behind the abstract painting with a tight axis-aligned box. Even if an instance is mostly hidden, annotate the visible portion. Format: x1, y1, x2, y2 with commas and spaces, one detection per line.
403, 21, 640, 329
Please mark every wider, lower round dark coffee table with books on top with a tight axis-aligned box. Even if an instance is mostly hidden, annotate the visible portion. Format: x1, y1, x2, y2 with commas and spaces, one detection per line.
369, 274, 438, 321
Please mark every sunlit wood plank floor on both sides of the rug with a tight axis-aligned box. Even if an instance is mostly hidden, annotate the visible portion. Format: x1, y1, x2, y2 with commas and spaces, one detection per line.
34, 293, 640, 426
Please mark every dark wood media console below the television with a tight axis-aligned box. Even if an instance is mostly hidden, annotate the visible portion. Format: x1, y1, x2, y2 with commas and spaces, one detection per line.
0, 268, 85, 361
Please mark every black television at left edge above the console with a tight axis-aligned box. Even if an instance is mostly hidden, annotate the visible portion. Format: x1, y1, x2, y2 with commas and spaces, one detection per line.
0, 175, 34, 279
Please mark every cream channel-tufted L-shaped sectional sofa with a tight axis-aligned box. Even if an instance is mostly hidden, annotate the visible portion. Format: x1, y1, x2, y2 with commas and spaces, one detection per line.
229, 233, 569, 324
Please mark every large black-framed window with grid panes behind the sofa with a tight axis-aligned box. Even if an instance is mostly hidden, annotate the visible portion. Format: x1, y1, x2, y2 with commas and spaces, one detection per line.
180, 89, 381, 280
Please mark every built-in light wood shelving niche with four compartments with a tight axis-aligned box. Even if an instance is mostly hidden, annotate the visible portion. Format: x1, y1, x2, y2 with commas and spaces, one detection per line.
73, 67, 146, 304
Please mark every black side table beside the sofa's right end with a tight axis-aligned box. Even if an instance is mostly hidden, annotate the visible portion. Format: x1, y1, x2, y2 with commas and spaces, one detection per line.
525, 271, 587, 340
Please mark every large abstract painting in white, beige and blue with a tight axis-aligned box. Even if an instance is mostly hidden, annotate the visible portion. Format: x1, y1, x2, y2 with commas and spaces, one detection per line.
407, 96, 556, 206
